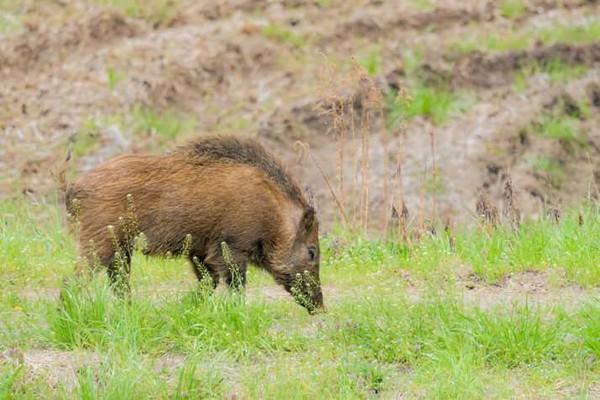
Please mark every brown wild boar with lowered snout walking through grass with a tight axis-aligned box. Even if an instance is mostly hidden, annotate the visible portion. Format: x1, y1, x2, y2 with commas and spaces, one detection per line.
65, 136, 323, 313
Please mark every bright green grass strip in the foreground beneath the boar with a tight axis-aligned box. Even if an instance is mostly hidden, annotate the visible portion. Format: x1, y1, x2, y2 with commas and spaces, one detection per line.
0, 202, 600, 399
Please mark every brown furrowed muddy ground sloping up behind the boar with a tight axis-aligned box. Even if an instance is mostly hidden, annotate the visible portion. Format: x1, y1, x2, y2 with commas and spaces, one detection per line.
0, 0, 600, 231
